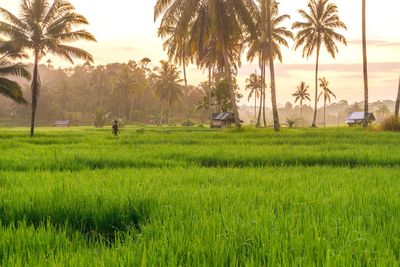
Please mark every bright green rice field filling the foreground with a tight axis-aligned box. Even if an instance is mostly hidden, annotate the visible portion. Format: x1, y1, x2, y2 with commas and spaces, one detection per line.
0, 127, 400, 266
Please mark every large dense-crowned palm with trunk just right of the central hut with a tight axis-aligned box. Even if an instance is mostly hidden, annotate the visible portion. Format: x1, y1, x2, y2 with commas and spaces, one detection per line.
154, 0, 255, 128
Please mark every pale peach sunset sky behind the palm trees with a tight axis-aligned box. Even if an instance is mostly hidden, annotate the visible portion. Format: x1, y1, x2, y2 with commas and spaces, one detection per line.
0, 0, 400, 105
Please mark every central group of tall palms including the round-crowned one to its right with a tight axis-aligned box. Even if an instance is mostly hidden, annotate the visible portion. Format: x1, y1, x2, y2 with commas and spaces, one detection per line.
154, 0, 346, 131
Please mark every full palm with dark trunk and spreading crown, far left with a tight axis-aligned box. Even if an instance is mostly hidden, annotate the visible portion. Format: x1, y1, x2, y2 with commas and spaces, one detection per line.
0, 0, 96, 136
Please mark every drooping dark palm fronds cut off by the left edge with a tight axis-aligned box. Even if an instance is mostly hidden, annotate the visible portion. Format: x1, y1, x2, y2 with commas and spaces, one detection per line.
0, 41, 31, 105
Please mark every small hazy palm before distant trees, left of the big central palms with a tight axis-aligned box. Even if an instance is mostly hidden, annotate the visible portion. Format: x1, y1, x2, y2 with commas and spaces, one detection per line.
155, 60, 183, 124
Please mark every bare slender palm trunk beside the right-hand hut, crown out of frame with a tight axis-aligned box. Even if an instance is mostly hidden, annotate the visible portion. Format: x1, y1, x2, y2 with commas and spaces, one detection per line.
362, 0, 368, 127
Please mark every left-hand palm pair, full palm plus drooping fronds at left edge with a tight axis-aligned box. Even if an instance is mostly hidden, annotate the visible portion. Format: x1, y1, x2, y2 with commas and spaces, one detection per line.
0, 0, 96, 136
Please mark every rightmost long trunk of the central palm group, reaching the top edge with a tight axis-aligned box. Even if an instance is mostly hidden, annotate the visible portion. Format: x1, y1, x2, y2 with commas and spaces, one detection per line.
267, 0, 281, 132
